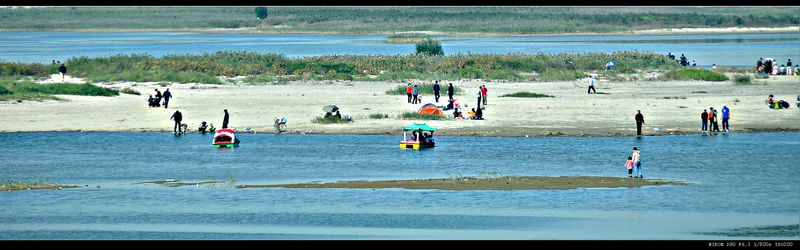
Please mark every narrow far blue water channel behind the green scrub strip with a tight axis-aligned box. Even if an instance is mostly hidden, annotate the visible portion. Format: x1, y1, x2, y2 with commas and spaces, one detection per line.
0, 32, 800, 68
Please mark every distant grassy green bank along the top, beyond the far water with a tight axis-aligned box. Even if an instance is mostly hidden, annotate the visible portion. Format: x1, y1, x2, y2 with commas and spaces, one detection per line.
0, 6, 800, 35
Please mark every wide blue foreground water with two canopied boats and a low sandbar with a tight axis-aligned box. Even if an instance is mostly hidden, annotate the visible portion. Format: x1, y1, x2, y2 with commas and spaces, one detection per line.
0, 132, 800, 240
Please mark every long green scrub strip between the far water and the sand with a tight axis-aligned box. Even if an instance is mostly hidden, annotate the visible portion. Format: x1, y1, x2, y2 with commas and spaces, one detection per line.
0, 51, 680, 83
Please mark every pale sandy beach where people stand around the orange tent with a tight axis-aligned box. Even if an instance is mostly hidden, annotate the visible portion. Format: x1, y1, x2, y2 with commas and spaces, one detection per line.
0, 71, 800, 137
